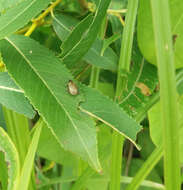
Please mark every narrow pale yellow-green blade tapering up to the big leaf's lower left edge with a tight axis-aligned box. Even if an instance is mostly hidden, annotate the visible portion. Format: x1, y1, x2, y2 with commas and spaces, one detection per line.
18, 120, 43, 190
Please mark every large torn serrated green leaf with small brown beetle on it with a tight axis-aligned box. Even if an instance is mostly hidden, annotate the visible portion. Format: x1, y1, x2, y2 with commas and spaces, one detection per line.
0, 36, 141, 168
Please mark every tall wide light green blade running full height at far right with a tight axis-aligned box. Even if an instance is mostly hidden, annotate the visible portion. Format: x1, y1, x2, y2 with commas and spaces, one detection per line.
151, 0, 180, 190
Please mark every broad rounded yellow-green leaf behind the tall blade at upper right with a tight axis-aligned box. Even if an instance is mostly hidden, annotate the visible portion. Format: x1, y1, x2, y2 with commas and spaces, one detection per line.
137, 0, 183, 68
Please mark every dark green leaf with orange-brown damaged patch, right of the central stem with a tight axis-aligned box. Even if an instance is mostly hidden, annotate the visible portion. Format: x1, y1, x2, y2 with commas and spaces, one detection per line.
120, 45, 158, 117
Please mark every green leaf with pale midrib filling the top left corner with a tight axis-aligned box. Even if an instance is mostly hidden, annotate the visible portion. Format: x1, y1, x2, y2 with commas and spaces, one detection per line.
0, 0, 50, 39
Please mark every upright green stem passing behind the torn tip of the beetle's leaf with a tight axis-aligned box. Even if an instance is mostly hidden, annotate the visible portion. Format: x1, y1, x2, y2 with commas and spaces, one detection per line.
110, 0, 138, 190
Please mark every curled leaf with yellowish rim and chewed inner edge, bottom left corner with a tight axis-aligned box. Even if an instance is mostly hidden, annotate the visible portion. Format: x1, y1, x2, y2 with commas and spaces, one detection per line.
0, 127, 20, 190
